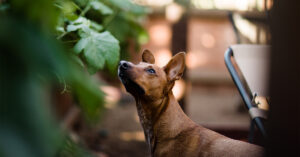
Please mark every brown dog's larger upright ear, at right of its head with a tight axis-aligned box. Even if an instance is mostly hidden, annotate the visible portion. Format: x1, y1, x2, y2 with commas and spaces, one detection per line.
164, 52, 185, 81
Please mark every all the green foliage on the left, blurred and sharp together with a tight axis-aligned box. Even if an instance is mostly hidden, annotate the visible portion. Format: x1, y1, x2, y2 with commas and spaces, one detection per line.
0, 0, 146, 157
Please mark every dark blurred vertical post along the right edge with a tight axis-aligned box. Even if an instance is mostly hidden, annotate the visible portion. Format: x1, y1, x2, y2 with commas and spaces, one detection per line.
266, 0, 300, 157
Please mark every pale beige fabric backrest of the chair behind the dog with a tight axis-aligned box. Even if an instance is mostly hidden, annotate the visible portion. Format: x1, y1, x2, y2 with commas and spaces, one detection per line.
231, 44, 271, 97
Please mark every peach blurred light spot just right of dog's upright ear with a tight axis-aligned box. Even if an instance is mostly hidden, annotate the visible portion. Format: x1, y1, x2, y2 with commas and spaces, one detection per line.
186, 51, 208, 69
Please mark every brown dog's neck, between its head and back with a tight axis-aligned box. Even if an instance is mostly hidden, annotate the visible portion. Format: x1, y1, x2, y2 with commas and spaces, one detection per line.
135, 92, 196, 154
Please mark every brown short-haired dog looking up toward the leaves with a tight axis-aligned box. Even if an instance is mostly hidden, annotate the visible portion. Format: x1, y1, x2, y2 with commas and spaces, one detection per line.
118, 50, 263, 157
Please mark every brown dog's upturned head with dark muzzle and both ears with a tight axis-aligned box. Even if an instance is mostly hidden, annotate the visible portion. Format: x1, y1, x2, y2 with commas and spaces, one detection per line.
118, 50, 185, 100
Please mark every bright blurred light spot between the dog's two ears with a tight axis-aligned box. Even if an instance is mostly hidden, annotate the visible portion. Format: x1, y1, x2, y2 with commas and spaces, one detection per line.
154, 49, 172, 67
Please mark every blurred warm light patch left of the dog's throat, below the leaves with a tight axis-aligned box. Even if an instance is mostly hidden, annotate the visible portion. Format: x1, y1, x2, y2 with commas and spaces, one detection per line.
100, 86, 121, 109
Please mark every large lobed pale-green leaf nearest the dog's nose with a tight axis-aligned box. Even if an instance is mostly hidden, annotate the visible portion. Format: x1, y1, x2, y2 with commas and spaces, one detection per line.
74, 29, 120, 73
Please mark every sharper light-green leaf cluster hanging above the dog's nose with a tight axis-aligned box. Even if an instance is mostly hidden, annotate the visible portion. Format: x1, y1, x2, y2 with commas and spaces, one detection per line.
55, 0, 147, 74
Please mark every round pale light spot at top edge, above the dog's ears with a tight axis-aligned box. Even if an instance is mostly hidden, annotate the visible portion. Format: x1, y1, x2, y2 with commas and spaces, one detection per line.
166, 3, 184, 23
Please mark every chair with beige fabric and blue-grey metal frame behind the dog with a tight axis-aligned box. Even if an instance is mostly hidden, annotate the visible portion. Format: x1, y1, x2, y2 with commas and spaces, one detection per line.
225, 45, 270, 142
